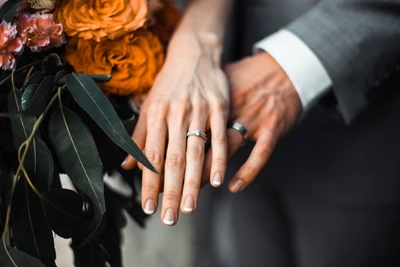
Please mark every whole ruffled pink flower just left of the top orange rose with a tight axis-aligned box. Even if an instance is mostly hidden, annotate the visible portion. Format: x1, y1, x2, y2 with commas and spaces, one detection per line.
17, 14, 66, 52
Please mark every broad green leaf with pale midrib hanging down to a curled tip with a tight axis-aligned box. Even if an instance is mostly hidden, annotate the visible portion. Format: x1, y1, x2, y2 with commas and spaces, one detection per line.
49, 107, 106, 245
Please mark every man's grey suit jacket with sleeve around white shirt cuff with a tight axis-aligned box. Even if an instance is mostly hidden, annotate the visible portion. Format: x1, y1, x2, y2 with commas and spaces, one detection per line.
223, 0, 400, 204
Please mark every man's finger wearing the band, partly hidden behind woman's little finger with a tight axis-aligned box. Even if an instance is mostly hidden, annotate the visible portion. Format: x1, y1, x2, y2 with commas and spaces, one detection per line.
201, 128, 243, 187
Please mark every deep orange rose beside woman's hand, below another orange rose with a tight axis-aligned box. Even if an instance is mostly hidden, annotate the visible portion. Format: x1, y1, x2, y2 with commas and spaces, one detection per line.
65, 29, 164, 96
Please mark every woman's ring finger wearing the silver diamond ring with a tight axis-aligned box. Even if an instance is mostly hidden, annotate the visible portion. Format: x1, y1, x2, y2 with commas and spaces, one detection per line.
181, 120, 207, 214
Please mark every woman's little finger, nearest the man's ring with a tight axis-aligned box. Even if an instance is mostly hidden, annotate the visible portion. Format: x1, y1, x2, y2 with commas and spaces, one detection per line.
210, 103, 228, 187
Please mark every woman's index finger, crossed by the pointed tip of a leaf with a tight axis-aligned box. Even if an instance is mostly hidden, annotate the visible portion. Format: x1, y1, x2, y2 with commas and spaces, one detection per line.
142, 115, 167, 214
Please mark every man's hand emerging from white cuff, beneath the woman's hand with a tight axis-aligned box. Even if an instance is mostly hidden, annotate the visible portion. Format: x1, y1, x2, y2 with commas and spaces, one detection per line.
203, 53, 302, 193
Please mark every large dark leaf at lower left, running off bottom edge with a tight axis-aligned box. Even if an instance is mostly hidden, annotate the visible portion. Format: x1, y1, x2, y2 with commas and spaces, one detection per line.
11, 176, 56, 267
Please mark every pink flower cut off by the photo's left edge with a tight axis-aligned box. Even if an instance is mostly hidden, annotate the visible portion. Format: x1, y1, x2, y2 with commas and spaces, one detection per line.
0, 21, 24, 70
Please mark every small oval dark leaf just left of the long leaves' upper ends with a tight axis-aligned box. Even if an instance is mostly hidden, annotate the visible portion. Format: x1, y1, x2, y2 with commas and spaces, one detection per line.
22, 76, 54, 115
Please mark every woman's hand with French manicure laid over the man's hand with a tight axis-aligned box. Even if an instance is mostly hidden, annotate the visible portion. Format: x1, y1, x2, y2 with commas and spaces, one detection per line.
123, 33, 229, 225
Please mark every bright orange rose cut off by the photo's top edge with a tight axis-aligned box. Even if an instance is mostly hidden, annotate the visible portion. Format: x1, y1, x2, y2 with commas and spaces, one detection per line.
54, 0, 148, 42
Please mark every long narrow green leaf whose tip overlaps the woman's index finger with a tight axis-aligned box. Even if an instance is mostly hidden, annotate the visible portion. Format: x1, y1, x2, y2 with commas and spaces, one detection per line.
66, 73, 157, 172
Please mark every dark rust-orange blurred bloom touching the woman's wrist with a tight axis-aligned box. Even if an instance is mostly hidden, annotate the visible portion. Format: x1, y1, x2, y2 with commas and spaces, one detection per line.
149, 1, 182, 46
